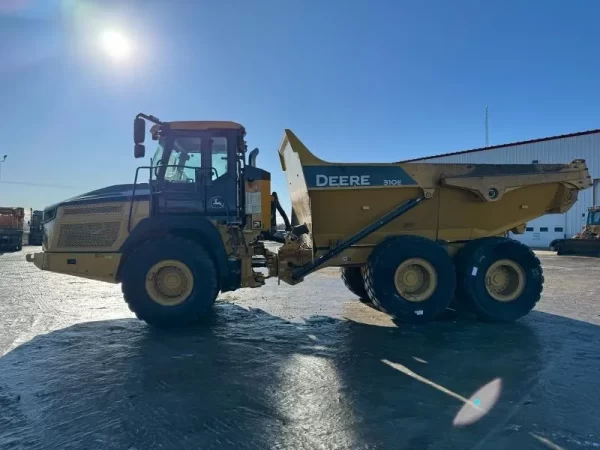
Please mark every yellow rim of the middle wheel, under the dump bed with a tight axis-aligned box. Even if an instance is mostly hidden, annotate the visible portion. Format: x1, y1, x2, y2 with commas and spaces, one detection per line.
394, 258, 437, 302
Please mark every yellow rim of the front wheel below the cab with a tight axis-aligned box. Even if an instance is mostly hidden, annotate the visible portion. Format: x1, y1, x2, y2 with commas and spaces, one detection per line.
146, 259, 194, 306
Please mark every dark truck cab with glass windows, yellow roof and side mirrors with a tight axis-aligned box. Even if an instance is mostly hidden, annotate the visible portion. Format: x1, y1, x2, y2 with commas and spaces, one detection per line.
134, 116, 271, 232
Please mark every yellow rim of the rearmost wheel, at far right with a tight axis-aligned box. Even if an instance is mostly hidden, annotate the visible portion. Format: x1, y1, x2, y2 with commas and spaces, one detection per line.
485, 259, 525, 303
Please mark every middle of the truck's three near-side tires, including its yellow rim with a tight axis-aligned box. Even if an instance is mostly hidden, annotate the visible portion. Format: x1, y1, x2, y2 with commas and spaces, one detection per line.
364, 236, 456, 323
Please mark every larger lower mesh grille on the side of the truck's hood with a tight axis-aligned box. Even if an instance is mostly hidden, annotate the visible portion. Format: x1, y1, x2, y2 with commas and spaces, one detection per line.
58, 221, 121, 248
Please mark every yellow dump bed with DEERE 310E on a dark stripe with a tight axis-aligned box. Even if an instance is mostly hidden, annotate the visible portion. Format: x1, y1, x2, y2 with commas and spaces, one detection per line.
279, 130, 592, 251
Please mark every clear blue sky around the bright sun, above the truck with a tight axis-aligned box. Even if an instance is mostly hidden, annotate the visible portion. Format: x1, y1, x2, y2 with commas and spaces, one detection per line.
0, 0, 600, 214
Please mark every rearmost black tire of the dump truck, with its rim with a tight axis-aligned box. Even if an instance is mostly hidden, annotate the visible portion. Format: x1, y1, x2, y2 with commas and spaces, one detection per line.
455, 237, 544, 322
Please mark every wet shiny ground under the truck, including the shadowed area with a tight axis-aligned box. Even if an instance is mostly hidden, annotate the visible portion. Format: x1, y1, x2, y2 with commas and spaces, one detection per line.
0, 247, 600, 450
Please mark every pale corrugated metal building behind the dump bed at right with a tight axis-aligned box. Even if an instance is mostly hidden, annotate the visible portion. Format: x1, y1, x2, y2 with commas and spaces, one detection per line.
406, 129, 600, 248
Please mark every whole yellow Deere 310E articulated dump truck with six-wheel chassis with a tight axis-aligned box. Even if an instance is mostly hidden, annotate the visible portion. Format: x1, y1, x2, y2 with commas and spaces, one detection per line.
27, 114, 591, 327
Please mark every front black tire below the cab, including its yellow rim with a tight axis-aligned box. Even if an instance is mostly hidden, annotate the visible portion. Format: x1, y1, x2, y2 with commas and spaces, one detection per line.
121, 237, 219, 327
